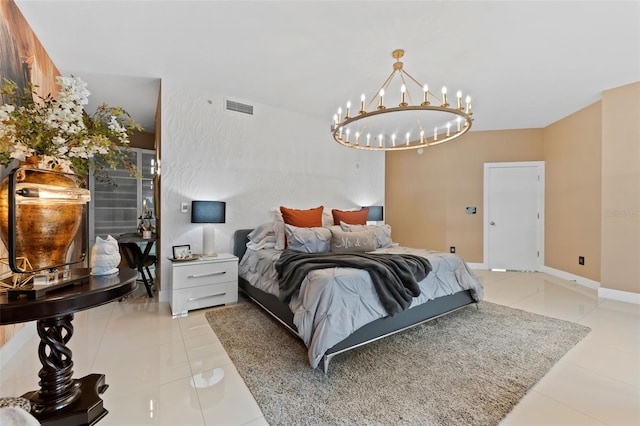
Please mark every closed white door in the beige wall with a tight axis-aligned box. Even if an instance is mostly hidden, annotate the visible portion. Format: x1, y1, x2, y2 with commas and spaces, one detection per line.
484, 161, 544, 271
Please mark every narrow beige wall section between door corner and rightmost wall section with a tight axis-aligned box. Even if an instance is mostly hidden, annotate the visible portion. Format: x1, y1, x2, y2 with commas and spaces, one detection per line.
543, 102, 602, 281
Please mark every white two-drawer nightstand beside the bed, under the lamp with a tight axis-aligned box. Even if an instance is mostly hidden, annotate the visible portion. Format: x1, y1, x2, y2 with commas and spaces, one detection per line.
171, 253, 238, 318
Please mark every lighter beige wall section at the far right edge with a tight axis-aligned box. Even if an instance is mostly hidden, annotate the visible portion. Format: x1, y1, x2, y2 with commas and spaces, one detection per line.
600, 82, 640, 293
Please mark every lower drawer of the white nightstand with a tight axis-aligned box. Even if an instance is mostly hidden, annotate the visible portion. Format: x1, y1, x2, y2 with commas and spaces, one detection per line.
171, 281, 238, 316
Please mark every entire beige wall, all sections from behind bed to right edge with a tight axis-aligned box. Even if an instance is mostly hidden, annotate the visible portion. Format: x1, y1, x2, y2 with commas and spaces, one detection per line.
385, 82, 640, 293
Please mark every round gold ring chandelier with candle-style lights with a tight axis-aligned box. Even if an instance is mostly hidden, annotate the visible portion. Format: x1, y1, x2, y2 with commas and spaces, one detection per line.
331, 49, 473, 151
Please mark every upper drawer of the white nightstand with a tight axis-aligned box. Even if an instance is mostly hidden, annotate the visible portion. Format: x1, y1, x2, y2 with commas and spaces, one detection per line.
173, 261, 238, 291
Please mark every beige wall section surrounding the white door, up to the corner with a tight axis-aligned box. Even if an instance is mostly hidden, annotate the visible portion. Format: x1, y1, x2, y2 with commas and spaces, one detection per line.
385, 129, 543, 263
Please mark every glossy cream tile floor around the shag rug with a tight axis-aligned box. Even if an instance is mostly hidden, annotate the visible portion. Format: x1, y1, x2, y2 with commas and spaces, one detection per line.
0, 271, 640, 426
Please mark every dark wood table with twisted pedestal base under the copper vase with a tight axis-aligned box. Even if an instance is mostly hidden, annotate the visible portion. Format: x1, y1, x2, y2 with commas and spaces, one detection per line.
0, 268, 138, 426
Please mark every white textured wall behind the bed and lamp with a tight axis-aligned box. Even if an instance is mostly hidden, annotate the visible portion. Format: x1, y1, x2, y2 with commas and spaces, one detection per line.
159, 80, 384, 300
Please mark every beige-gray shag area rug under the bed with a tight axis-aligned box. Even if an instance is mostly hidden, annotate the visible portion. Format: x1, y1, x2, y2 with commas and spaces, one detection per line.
206, 302, 589, 426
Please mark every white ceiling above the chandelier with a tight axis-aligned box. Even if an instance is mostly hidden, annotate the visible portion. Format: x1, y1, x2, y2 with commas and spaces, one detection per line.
16, 0, 640, 133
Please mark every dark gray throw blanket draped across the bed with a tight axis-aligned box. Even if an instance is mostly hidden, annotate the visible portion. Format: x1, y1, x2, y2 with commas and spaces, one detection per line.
276, 250, 431, 315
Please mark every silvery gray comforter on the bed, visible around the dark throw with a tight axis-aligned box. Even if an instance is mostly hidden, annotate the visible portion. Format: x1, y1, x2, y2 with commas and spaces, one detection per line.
239, 247, 483, 368
